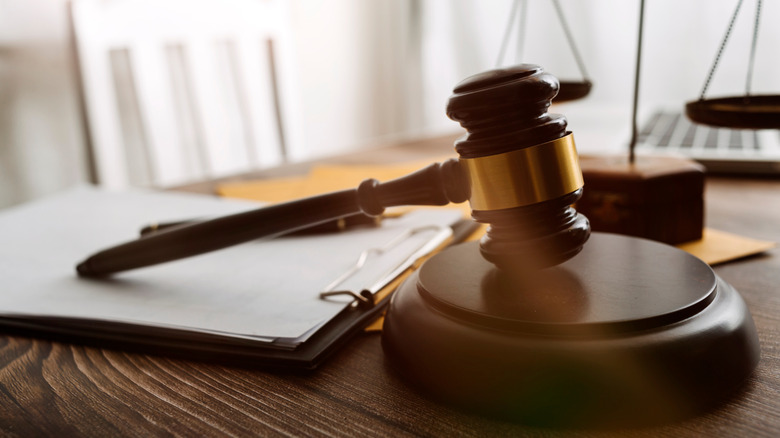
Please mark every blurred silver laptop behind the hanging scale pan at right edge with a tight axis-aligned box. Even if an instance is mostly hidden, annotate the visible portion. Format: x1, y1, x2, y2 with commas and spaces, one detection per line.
636, 110, 780, 175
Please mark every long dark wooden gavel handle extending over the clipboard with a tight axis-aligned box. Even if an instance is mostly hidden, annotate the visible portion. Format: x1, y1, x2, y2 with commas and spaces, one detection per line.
76, 159, 469, 277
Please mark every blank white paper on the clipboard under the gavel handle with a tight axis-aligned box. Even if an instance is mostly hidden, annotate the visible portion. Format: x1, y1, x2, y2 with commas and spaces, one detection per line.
0, 187, 460, 344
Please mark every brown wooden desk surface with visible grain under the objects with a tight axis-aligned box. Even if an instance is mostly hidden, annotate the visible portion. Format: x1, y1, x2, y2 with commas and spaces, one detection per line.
0, 137, 780, 437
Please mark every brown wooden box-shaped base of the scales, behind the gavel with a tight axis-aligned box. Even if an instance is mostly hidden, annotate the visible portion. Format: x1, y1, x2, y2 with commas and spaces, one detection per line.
576, 156, 704, 244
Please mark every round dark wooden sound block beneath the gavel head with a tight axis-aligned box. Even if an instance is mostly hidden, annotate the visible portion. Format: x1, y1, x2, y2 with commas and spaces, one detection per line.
382, 233, 759, 426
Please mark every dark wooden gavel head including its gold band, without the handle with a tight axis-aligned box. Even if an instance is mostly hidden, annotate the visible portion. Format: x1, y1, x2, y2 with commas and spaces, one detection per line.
447, 64, 590, 272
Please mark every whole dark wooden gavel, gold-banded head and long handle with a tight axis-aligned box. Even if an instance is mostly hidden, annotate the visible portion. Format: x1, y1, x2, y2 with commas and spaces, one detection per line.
77, 64, 590, 277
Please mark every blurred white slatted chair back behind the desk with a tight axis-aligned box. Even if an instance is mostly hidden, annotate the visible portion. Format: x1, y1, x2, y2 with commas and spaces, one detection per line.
70, 0, 305, 188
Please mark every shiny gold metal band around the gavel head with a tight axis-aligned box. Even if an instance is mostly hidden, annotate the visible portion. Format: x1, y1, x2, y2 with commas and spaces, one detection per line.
459, 133, 584, 210
